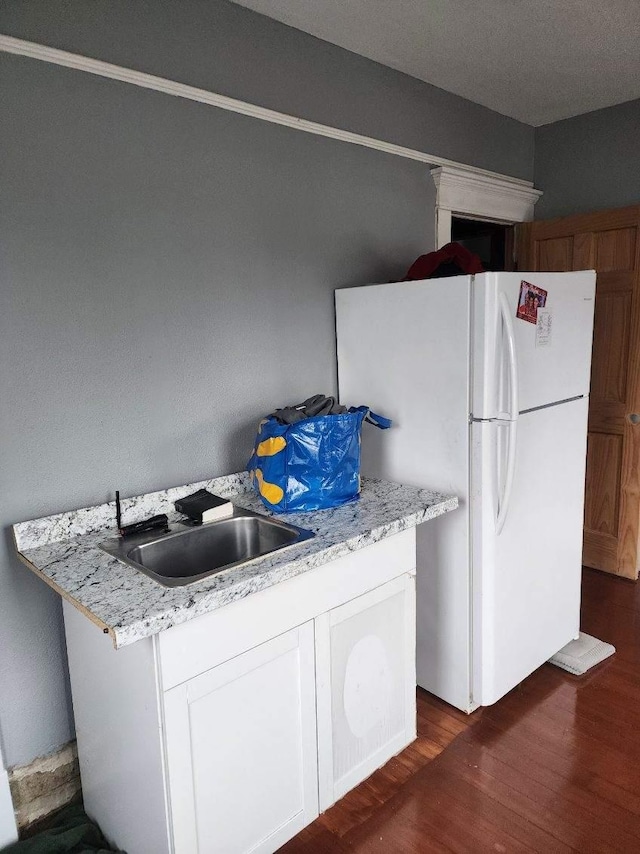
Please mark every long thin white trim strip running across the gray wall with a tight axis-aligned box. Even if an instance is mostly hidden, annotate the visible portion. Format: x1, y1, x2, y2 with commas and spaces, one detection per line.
0, 34, 530, 187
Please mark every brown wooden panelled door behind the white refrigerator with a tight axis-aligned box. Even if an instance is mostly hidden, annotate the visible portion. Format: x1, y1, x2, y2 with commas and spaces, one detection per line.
518, 206, 640, 579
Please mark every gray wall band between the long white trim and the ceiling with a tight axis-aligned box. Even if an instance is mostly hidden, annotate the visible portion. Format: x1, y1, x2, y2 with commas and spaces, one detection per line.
0, 0, 534, 180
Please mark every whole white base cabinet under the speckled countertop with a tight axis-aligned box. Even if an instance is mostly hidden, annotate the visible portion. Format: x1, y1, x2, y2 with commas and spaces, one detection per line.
64, 529, 416, 854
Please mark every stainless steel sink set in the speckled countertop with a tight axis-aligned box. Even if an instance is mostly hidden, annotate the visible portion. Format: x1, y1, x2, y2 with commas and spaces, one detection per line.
100, 509, 315, 587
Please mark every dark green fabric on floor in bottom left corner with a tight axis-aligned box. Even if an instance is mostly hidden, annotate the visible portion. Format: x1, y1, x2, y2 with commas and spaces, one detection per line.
2, 806, 125, 854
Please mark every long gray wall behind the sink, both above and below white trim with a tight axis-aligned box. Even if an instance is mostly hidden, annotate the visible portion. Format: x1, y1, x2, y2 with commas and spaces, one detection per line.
0, 0, 533, 764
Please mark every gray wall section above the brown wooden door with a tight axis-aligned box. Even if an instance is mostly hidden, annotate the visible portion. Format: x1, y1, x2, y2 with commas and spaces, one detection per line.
535, 100, 640, 219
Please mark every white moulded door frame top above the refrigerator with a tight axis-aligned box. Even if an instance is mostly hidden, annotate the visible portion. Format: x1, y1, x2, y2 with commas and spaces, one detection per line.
431, 165, 542, 248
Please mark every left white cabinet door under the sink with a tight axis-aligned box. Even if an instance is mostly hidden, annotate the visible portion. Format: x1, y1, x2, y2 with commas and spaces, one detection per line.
164, 621, 318, 854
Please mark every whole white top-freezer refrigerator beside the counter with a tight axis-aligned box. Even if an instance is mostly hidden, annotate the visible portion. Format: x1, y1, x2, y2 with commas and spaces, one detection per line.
335, 271, 595, 712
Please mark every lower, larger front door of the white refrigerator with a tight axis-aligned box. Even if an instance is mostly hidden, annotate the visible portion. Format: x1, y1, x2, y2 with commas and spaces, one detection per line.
471, 398, 588, 705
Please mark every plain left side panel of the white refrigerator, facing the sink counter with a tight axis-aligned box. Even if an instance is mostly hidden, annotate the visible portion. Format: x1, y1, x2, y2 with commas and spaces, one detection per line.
336, 276, 472, 711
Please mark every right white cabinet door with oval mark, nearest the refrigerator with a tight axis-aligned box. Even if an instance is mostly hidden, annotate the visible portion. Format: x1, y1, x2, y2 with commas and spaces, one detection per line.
316, 575, 416, 811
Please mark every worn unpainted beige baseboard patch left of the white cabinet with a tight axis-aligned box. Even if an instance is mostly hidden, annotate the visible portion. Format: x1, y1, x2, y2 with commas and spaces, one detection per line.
9, 741, 81, 834
